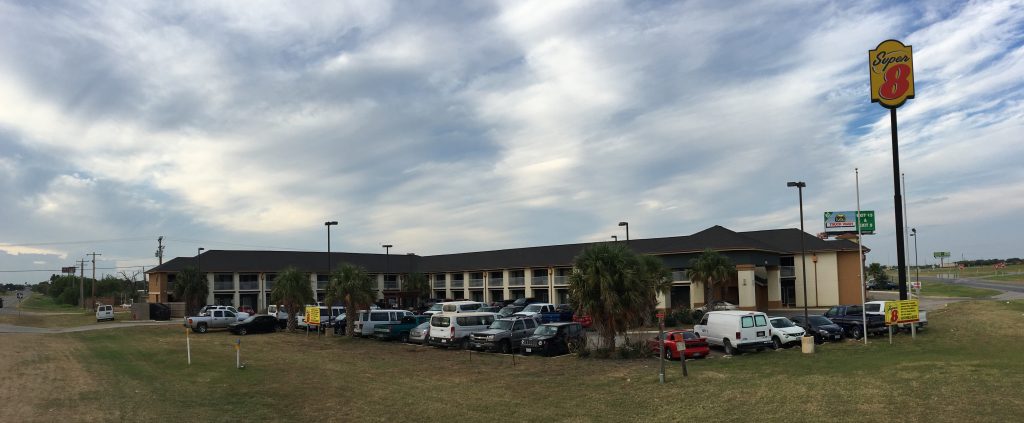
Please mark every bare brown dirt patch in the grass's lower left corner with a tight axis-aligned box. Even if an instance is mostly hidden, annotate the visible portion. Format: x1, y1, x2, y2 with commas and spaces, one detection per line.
0, 334, 104, 422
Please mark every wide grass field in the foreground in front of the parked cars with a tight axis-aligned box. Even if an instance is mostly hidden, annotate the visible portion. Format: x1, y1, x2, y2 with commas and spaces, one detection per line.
0, 301, 1024, 422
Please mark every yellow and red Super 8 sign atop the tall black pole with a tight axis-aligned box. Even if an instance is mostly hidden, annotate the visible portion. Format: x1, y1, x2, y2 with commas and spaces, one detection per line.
867, 40, 913, 109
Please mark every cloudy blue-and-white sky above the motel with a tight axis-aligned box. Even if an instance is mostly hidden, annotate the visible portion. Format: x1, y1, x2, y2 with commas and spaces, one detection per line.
0, 0, 1024, 283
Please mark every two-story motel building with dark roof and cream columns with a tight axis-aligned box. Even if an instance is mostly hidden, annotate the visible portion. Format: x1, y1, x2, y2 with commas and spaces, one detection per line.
147, 226, 867, 311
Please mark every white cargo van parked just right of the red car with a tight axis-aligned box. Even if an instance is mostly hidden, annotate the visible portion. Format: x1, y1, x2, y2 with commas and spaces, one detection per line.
693, 310, 772, 355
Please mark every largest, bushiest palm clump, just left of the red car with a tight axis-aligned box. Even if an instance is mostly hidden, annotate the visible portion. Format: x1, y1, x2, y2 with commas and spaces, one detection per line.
569, 243, 671, 350
